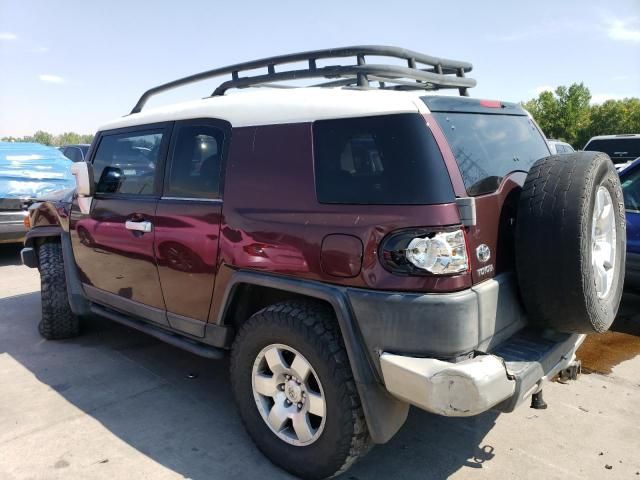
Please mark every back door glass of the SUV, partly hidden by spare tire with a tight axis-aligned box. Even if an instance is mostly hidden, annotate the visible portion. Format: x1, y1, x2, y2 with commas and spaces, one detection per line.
433, 112, 549, 195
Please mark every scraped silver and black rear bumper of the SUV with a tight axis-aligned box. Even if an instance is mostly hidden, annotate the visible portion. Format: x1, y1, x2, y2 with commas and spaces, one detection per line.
380, 331, 585, 417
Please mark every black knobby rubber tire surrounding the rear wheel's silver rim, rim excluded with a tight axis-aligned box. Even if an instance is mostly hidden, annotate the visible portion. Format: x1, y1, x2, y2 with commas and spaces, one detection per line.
231, 301, 372, 479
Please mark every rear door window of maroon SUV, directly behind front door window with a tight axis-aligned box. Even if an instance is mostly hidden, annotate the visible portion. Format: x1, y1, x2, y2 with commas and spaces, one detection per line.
164, 125, 223, 198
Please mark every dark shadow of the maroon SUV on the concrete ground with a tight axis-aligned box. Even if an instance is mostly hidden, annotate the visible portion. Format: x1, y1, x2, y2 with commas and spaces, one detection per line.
0, 292, 498, 480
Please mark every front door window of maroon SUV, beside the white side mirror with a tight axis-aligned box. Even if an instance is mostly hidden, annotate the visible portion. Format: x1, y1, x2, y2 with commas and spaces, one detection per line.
93, 130, 163, 195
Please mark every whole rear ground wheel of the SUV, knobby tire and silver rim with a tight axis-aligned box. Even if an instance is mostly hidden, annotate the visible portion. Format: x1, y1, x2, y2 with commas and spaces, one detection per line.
231, 301, 371, 479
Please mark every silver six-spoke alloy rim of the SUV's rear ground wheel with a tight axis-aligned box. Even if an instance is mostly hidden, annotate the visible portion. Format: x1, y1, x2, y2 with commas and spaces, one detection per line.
251, 344, 326, 446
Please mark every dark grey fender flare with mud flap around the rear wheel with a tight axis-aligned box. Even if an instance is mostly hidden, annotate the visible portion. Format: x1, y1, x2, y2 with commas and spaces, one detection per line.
216, 270, 409, 443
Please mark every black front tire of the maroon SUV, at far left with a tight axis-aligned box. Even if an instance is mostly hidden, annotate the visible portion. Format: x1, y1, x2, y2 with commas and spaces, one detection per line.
38, 242, 80, 340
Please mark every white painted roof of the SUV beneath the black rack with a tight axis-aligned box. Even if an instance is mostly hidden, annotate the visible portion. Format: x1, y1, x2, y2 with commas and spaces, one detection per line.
100, 87, 432, 130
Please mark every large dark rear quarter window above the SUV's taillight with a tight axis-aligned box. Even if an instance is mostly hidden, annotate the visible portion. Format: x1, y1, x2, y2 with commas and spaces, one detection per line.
313, 114, 455, 205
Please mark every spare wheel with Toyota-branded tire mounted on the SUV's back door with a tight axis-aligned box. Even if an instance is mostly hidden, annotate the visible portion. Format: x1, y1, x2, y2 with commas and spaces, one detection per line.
515, 152, 627, 333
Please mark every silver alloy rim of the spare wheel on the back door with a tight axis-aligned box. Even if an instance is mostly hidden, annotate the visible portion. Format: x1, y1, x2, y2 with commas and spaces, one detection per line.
591, 186, 617, 298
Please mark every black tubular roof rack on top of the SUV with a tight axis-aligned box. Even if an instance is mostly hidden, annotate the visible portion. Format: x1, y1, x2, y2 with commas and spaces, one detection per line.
131, 45, 476, 114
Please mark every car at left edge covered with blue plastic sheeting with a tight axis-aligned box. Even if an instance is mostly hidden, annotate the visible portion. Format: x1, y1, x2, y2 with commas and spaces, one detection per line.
0, 142, 75, 243
